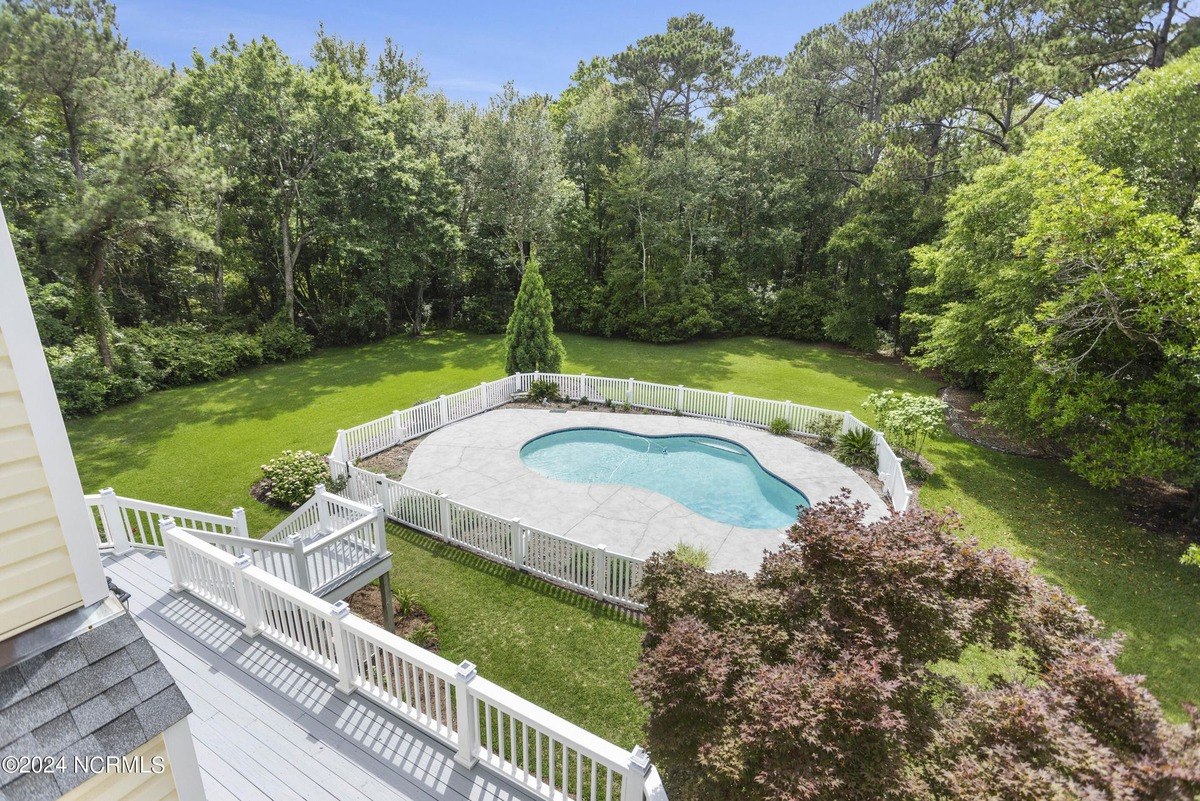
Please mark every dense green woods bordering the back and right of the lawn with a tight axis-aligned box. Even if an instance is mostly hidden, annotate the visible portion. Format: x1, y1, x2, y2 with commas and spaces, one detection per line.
0, 0, 1200, 510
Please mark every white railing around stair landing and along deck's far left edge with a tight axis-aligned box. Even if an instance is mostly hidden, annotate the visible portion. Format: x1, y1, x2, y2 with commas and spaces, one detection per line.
93, 486, 388, 594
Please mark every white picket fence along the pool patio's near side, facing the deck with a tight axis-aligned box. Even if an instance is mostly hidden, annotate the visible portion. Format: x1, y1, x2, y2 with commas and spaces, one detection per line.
330, 459, 646, 610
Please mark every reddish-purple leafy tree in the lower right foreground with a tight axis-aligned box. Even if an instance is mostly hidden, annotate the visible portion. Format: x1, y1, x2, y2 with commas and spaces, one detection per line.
634, 498, 1200, 801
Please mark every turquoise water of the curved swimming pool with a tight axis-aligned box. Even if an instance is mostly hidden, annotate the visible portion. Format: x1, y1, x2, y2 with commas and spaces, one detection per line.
521, 428, 809, 529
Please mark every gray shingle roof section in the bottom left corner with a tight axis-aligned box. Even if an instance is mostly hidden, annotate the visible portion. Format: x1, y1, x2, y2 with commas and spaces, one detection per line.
0, 614, 192, 801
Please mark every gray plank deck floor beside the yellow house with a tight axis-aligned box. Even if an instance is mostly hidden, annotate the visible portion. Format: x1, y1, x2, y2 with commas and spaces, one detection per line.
104, 549, 534, 801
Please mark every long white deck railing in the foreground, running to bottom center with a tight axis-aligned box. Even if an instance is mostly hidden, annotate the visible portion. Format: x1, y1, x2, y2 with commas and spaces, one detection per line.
160, 520, 666, 801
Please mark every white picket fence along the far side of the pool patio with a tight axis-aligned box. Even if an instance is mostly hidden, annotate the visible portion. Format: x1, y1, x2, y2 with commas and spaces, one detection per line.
330, 373, 912, 512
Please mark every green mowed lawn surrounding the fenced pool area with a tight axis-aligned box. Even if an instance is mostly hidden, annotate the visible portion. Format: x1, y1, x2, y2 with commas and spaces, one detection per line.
70, 333, 1200, 746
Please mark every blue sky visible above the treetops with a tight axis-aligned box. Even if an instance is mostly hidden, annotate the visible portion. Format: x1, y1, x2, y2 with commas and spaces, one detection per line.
116, 0, 866, 102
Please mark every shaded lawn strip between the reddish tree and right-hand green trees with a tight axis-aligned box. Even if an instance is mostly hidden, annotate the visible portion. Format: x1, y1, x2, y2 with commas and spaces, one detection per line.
924, 440, 1200, 716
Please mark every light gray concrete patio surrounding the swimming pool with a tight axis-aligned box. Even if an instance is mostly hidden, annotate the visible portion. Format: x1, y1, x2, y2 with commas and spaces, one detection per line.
403, 409, 888, 573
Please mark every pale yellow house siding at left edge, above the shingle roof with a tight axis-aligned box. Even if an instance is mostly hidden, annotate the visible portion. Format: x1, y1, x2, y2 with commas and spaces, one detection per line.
0, 335, 83, 639
